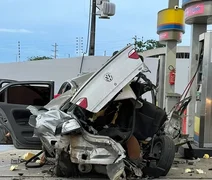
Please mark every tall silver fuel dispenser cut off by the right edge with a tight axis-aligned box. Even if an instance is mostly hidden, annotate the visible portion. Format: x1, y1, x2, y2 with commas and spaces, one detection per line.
194, 32, 212, 151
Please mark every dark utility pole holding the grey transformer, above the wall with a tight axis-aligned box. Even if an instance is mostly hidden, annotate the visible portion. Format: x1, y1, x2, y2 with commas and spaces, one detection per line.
89, 0, 96, 56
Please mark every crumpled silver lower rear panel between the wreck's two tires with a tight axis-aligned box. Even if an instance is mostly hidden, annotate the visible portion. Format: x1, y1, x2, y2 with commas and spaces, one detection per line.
70, 130, 126, 165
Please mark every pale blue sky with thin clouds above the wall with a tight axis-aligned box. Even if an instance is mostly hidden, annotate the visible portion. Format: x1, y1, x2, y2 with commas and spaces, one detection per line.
0, 0, 210, 63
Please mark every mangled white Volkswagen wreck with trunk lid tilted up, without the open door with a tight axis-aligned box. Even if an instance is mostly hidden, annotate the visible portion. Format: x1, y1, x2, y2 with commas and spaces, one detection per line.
21, 46, 175, 180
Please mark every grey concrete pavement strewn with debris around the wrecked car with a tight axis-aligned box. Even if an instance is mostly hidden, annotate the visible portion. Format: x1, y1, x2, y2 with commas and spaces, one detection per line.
0, 146, 212, 180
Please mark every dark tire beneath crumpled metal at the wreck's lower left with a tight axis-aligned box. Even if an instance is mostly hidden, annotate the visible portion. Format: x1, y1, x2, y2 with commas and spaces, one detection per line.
55, 151, 80, 178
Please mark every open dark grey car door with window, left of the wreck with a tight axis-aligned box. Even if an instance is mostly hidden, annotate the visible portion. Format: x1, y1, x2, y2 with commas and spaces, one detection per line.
0, 81, 54, 149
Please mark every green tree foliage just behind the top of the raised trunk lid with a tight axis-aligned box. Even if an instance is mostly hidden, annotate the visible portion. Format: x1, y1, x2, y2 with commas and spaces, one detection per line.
134, 36, 165, 52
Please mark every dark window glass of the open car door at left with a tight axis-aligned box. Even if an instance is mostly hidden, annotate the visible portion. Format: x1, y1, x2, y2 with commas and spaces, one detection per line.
7, 85, 51, 106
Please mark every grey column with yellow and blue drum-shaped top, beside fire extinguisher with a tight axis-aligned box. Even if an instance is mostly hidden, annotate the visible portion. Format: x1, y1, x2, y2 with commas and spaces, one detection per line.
157, 0, 185, 112
